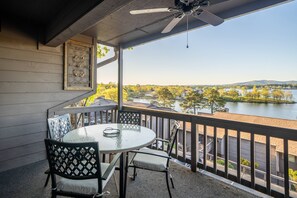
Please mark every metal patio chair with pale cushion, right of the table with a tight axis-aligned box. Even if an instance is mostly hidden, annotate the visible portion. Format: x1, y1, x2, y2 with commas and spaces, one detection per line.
129, 121, 180, 197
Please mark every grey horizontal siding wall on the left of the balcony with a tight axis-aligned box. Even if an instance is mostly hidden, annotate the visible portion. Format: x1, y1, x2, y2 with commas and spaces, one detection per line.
0, 24, 92, 172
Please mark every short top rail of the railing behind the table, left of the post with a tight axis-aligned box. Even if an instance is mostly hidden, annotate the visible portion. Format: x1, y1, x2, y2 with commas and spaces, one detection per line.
55, 105, 117, 115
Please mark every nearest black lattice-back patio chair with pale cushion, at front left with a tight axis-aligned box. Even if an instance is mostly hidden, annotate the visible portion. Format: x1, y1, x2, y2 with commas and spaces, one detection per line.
45, 139, 120, 197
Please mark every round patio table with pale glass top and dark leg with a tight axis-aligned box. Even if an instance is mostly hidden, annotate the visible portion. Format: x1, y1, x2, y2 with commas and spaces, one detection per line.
63, 124, 156, 197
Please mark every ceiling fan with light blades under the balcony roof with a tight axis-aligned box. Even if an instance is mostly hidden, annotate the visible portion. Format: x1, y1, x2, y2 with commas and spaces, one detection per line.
130, 0, 224, 33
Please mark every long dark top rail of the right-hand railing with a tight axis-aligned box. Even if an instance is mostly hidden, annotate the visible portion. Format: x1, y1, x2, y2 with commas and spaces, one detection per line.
123, 106, 297, 141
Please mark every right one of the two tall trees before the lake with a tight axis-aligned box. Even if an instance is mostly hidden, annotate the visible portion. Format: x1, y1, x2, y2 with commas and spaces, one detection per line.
203, 87, 226, 113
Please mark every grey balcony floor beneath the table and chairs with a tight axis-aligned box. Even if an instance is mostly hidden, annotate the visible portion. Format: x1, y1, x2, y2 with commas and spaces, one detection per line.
0, 161, 255, 198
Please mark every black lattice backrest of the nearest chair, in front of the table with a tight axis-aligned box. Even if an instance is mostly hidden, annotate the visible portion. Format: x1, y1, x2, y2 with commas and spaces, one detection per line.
44, 139, 102, 189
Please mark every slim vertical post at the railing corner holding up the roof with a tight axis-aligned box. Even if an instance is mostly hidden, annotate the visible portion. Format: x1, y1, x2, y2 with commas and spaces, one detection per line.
118, 46, 123, 110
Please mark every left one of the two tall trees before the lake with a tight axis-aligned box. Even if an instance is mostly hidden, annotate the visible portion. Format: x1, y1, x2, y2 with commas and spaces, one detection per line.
181, 90, 204, 114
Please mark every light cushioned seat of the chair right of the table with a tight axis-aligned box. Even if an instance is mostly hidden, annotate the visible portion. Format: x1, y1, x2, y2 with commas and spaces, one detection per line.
133, 148, 168, 171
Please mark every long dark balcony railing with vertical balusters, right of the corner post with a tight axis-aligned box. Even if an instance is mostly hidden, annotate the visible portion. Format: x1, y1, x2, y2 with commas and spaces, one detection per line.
123, 106, 297, 197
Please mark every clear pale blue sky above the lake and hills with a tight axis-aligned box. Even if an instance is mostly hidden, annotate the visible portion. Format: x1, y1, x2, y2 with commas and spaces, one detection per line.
97, 1, 297, 85
